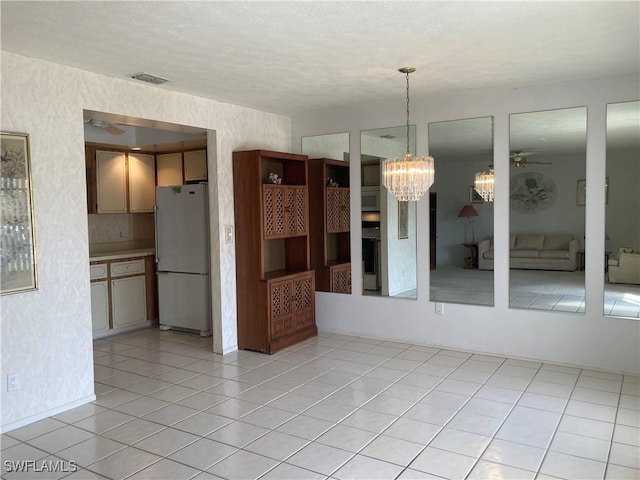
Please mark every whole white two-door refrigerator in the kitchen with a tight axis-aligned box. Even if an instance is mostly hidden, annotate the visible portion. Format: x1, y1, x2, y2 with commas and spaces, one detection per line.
155, 184, 212, 336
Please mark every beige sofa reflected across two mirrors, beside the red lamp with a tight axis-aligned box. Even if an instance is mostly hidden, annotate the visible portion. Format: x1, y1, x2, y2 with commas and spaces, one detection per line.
478, 234, 578, 271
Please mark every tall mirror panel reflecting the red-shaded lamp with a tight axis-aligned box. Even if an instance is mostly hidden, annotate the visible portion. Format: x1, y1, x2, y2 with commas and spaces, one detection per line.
429, 117, 494, 305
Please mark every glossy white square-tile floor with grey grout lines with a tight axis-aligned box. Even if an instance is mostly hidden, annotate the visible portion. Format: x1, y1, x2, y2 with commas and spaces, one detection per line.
2, 328, 640, 480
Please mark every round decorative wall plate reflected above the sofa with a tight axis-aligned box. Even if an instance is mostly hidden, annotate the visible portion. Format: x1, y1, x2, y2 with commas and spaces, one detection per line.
509, 172, 557, 213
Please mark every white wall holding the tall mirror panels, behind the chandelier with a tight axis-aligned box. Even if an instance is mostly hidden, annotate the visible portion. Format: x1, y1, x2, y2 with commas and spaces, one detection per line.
292, 75, 640, 374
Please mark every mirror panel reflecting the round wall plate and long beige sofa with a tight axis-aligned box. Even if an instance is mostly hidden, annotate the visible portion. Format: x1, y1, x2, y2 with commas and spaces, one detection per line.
509, 107, 588, 313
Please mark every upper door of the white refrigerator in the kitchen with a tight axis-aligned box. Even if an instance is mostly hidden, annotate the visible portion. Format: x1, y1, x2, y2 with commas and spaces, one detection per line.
156, 184, 209, 274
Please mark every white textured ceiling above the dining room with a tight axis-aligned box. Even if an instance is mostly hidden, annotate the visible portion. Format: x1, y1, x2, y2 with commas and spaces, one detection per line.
0, 1, 640, 117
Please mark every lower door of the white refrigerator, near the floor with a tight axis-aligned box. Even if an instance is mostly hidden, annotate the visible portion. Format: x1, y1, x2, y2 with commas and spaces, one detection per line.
158, 272, 211, 334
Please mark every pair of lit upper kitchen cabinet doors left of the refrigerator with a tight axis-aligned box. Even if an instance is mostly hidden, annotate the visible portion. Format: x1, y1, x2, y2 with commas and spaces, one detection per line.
93, 150, 155, 213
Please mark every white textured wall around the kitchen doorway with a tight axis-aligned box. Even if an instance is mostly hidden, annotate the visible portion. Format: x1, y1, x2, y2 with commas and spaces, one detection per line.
0, 52, 291, 430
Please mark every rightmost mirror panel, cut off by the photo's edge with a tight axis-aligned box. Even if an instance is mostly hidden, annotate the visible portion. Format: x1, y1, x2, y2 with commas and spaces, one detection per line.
604, 102, 640, 319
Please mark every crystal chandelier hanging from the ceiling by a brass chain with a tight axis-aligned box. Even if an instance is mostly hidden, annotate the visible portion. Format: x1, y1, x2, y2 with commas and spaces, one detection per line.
382, 67, 435, 202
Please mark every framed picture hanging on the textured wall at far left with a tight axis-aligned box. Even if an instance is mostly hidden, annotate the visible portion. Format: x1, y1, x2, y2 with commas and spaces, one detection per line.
0, 132, 37, 294
